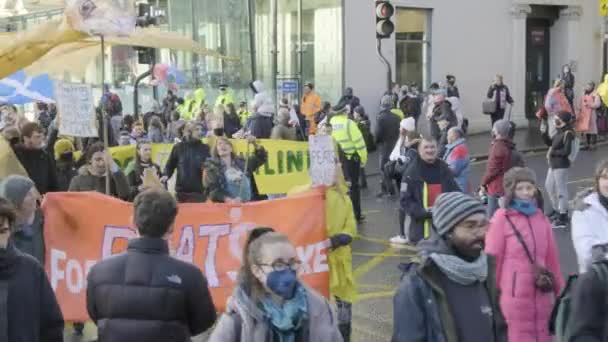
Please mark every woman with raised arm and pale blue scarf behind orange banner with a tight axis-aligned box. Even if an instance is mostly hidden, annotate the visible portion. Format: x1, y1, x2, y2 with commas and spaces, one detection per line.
203, 137, 268, 203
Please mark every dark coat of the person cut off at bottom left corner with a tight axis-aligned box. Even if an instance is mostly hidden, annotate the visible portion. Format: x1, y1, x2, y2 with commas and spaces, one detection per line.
0, 242, 64, 342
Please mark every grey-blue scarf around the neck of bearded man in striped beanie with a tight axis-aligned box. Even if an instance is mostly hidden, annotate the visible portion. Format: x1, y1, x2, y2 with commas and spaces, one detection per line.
429, 253, 488, 286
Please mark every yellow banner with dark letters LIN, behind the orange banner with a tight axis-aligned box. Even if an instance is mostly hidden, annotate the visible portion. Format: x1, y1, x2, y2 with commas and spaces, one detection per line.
94, 140, 310, 194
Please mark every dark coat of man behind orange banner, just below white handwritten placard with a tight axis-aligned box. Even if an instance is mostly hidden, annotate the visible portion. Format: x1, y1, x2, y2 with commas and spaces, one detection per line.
68, 165, 130, 201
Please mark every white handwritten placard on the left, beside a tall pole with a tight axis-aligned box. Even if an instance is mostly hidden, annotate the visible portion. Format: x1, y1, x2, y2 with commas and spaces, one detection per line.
55, 81, 97, 137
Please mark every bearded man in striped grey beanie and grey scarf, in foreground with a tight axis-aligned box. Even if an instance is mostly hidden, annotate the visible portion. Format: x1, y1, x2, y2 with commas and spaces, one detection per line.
392, 192, 507, 342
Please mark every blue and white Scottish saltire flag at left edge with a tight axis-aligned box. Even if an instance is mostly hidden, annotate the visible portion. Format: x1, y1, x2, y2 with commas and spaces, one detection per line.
0, 71, 55, 105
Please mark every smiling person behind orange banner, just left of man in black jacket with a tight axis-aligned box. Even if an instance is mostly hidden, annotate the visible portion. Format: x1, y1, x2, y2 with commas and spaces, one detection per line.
125, 139, 162, 199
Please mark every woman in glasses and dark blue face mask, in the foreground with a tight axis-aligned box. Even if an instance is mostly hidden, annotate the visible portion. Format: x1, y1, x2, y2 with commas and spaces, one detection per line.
209, 228, 343, 342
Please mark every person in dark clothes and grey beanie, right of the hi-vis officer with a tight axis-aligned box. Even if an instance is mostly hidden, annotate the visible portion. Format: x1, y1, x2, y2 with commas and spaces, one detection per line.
374, 95, 401, 197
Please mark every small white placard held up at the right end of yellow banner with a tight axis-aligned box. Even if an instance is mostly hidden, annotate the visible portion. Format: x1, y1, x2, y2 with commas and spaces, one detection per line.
308, 135, 336, 186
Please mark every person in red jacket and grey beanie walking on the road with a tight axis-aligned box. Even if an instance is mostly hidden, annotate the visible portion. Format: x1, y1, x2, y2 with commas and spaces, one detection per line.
480, 119, 515, 218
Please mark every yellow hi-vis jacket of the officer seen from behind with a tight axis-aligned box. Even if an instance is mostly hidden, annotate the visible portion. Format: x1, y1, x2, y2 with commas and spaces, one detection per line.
329, 114, 367, 165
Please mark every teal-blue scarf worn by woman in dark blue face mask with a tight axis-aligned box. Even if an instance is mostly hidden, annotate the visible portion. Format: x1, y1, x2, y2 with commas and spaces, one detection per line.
262, 285, 308, 342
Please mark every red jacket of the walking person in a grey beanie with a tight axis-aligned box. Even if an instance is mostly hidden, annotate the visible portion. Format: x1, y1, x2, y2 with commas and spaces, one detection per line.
481, 139, 514, 196
